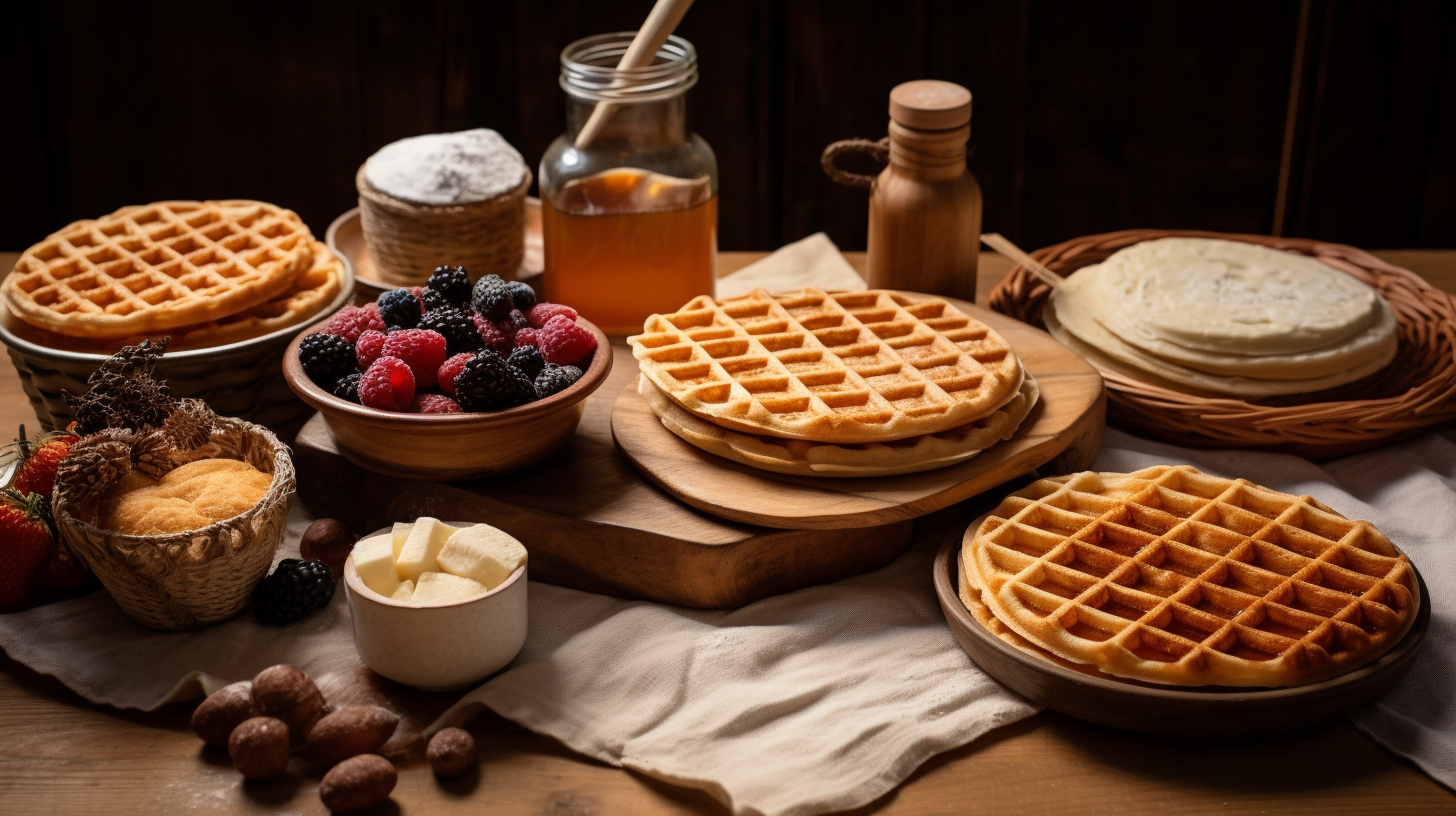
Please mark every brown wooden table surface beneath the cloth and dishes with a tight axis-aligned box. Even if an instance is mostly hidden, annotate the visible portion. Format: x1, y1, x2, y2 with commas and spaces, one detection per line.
0, 251, 1456, 816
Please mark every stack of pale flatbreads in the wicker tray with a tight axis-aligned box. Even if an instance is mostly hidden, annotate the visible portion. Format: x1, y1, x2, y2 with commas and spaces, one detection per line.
1042, 238, 1396, 398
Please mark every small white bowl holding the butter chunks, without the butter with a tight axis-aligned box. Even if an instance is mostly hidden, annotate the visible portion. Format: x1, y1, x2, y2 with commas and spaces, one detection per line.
344, 522, 526, 691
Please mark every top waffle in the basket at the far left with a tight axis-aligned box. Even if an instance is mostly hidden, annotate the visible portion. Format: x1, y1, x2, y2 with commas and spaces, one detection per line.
3, 201, 313, 338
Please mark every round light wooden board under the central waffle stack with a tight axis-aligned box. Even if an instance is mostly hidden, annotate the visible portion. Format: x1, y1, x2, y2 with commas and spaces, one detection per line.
612, 294, 1107, 530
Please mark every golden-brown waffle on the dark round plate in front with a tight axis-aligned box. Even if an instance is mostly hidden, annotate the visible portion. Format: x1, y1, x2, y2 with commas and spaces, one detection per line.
962, 466, 1420, 686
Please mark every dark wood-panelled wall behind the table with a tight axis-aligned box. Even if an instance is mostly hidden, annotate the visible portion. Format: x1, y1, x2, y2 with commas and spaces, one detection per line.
0, 0, 1456, 251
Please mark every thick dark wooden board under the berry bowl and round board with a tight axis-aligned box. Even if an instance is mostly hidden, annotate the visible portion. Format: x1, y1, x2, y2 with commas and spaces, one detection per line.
286, 341, 911, 608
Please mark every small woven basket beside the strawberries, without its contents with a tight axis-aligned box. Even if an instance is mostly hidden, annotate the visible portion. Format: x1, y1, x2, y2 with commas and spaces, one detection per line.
54, 417, 294, 629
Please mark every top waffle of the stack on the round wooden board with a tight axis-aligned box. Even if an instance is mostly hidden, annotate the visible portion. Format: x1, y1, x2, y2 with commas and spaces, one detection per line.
628, 287, 1022, 443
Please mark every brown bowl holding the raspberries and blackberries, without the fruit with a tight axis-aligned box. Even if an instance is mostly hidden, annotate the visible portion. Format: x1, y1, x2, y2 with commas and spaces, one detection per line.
282, 318, 612, 479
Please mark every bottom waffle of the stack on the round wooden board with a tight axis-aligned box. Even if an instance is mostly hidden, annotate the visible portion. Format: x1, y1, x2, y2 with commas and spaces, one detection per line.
638, 373, 1041, 478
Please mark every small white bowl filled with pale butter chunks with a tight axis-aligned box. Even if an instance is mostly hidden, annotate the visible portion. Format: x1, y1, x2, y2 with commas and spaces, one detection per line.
344, 519, 526, 691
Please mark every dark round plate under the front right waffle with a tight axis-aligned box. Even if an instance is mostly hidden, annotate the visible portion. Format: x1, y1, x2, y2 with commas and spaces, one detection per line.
935, 533, 1431, 737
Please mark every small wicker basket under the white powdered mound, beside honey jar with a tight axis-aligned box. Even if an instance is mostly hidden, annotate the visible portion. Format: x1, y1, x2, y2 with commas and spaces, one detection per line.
354, 165, 531, 286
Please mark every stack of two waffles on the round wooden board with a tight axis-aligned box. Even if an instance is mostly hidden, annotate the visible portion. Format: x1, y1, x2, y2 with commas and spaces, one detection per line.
628, 289, 1038, 476
